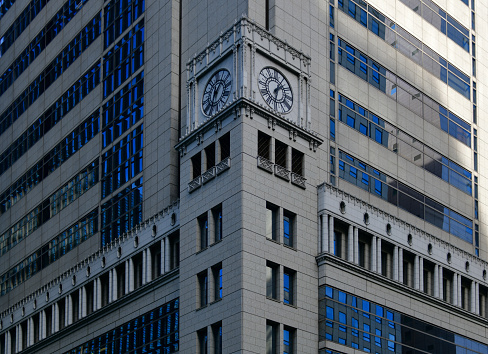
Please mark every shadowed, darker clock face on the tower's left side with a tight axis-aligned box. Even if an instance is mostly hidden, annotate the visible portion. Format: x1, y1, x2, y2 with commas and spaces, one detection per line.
202, 69, 232, 117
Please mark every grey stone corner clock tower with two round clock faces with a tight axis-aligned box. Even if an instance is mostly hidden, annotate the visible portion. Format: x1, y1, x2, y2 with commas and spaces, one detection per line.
176, 18, 323, 353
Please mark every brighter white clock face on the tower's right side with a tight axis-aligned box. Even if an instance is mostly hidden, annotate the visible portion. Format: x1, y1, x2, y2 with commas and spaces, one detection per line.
258, 66, 293, 113
